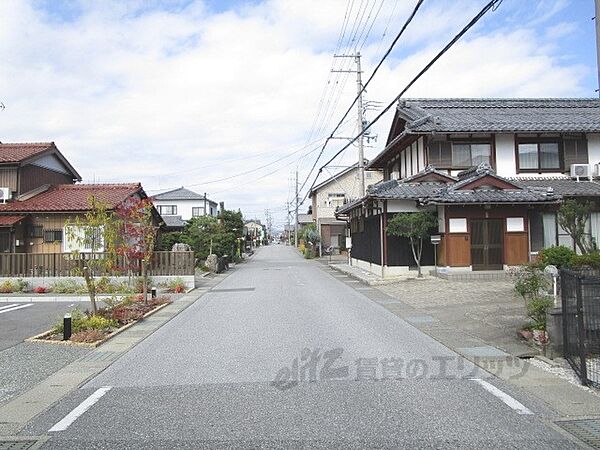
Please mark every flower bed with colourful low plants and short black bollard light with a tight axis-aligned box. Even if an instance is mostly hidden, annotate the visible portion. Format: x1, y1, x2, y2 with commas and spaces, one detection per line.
28, 294, 172, 347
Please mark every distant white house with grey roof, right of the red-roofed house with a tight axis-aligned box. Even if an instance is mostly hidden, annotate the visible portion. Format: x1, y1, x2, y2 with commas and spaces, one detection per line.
152, 186, 218, 231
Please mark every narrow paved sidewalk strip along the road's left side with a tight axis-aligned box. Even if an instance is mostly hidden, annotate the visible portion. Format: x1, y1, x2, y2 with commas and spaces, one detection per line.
0, 273, 229, 437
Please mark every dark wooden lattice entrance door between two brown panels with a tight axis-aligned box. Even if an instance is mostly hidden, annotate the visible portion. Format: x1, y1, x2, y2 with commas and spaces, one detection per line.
471, 219, 504, 270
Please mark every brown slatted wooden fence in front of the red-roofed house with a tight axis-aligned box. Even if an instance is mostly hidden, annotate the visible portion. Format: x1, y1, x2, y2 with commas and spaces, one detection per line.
0, 252, 195, 277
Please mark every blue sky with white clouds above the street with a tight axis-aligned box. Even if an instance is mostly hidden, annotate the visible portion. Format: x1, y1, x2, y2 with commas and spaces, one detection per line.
0, 0, 597, 223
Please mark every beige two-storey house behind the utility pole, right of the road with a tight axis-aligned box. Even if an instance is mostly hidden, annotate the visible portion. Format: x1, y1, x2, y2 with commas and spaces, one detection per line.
309, 164, 383, 250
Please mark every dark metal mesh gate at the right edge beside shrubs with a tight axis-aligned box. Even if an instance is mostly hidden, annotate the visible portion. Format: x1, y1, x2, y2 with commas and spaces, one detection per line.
560, 269, 600, 387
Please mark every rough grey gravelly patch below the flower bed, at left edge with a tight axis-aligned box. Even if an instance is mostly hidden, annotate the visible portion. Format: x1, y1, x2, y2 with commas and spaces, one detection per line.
0, 342, 90, 404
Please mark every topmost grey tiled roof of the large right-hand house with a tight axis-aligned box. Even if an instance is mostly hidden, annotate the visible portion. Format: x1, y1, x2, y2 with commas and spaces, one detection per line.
398, 98, 600, 133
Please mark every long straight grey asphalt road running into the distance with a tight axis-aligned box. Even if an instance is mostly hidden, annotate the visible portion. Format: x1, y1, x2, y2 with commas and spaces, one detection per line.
26, 246, 574, 449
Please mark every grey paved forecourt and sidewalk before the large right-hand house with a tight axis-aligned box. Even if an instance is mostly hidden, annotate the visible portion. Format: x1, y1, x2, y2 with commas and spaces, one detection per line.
323, 264, 600, 418
